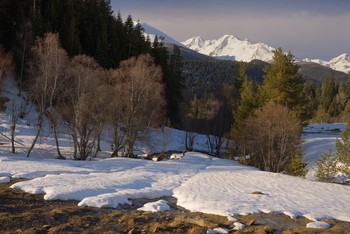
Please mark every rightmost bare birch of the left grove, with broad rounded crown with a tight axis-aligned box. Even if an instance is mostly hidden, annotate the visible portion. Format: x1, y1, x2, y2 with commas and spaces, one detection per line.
114, 55, 165, 157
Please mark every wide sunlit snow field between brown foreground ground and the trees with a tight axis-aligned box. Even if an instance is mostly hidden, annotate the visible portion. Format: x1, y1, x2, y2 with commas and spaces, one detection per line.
0, 153, 350, 222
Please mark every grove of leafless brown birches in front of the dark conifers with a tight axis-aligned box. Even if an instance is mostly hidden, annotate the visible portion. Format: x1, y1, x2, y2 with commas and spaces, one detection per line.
2, 33, 166, 160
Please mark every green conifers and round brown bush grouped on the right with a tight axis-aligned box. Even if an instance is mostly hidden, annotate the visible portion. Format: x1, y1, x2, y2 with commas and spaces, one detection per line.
232, 49, 350, 175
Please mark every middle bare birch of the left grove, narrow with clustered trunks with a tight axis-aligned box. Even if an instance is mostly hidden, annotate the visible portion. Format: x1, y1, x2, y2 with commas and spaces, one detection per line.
65, 55, 107, 160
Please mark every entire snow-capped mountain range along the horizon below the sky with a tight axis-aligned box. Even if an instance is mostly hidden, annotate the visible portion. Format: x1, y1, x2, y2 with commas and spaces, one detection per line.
141, 23, 350, 73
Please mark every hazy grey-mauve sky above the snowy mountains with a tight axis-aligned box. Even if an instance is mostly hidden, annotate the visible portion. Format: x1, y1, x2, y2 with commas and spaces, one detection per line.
111, 0, 350, 60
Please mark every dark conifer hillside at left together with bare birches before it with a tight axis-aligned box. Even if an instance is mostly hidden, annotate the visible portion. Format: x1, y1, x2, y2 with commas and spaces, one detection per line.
0, 0, 184, 159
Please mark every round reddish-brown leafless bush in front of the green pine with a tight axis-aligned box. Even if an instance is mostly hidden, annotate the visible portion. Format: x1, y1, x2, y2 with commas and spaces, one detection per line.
242, 103, 301, 172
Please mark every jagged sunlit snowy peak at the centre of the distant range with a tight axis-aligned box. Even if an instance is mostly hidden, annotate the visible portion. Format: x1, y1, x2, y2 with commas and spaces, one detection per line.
182, 35, 274, 62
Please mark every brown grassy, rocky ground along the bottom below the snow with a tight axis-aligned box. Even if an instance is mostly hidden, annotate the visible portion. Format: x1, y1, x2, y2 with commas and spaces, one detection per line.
0, 181, 350, 234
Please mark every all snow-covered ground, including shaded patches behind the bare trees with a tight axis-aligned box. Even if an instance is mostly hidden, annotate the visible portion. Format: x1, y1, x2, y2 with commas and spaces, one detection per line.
0, 76, 350, 222
